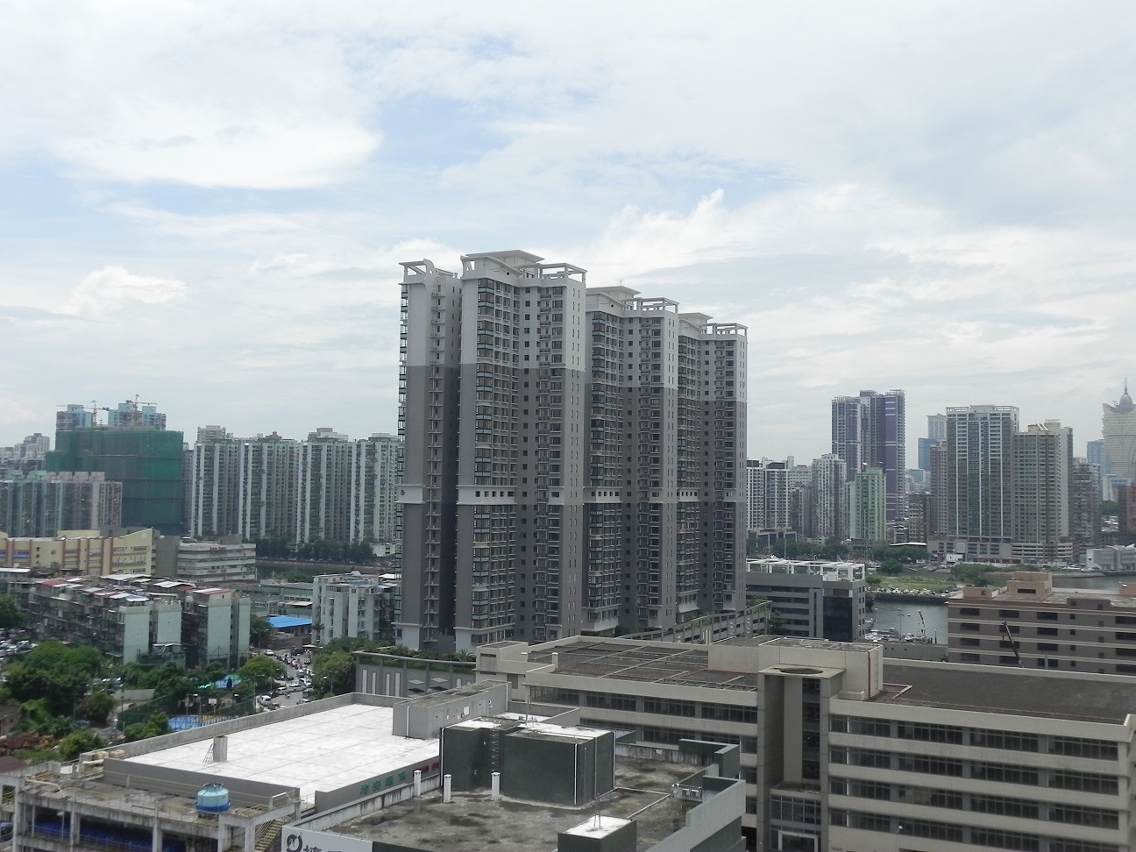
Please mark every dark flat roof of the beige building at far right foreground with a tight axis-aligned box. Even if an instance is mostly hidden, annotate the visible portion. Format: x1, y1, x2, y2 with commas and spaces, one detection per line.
875, 660, 1136, 724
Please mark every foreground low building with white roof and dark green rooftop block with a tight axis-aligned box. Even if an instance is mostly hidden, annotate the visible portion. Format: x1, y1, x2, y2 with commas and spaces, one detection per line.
0, 683, 744, 852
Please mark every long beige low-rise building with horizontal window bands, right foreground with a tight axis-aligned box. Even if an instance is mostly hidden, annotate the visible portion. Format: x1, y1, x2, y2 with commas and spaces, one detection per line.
477, 637, 1136, 852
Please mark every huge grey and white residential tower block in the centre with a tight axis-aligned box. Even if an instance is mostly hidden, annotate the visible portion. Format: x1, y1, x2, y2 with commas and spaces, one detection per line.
400, 251, 746, 650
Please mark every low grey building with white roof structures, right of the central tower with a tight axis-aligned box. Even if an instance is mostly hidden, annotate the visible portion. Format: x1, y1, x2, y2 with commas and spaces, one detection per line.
745, 557, 868, 642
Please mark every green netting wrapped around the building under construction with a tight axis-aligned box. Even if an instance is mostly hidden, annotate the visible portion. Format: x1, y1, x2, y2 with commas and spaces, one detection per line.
45, 428, 185, 535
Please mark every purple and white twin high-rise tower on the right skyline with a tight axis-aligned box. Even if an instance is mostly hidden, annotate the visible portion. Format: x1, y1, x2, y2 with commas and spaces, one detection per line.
833, 391, 907, 524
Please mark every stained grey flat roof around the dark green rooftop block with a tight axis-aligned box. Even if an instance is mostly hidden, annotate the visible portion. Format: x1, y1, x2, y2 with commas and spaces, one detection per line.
333, 758, 698, 852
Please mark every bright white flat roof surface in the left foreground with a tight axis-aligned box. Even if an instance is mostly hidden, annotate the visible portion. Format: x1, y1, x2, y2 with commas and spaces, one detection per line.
127, 704, 438, 802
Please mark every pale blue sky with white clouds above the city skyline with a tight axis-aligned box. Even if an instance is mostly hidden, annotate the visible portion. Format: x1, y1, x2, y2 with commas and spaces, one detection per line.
0, 0, 1136, 467
